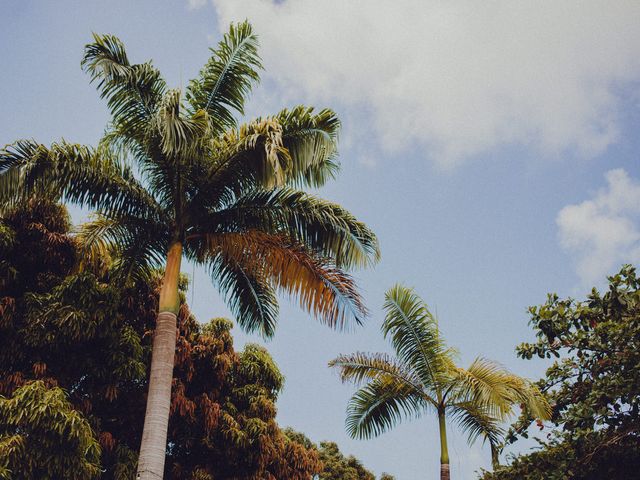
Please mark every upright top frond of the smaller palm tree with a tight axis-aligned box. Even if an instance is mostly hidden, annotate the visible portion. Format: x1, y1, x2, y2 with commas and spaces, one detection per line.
382, 285, 452, 389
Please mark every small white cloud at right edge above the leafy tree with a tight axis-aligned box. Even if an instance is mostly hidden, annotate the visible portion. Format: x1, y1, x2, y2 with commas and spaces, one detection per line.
556, 169, 640, 285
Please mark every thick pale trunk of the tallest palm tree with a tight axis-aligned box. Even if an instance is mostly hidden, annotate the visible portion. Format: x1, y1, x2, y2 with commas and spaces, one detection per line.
136, 242, 182, 480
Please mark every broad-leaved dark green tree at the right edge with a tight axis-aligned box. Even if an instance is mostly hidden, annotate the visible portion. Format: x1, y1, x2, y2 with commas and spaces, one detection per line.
484, 265, 640, 480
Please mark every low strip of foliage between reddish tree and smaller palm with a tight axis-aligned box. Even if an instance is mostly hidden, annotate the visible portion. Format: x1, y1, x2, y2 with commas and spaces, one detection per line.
285, 428, 394, 480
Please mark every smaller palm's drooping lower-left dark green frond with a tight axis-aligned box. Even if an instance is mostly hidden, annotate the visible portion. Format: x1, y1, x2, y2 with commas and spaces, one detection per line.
346, 377, 429, 439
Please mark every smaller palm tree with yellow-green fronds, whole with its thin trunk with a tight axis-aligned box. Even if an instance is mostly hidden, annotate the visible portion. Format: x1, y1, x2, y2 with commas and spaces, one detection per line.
329, 285, 550, 479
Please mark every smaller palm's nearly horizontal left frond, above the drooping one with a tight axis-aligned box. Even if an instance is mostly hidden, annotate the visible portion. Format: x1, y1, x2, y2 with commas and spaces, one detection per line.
329, 352, 436, 406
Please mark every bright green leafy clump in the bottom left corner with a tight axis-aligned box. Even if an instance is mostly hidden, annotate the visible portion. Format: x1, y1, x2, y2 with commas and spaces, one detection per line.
0, 381, 101, 480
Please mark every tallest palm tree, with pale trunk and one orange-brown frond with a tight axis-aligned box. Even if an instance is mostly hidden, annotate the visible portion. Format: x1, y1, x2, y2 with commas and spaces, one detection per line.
0, 22, 379, 480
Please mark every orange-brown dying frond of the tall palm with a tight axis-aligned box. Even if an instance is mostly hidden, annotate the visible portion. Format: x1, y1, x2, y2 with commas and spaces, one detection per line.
185, 230, 367, 328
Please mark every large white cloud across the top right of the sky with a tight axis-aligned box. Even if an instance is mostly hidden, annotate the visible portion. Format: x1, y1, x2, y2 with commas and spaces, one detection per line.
213, 0, 640, 166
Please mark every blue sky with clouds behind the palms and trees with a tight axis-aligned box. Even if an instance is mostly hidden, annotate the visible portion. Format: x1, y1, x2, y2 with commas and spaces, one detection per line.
0, 0, 640, 480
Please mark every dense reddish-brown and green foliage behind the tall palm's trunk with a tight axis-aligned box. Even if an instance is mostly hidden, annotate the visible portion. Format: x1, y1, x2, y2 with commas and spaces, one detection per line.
0, 201, 320, 480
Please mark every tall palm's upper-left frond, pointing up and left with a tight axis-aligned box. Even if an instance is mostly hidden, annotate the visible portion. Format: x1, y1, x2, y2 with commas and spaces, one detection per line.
82, 34, 166, 142
